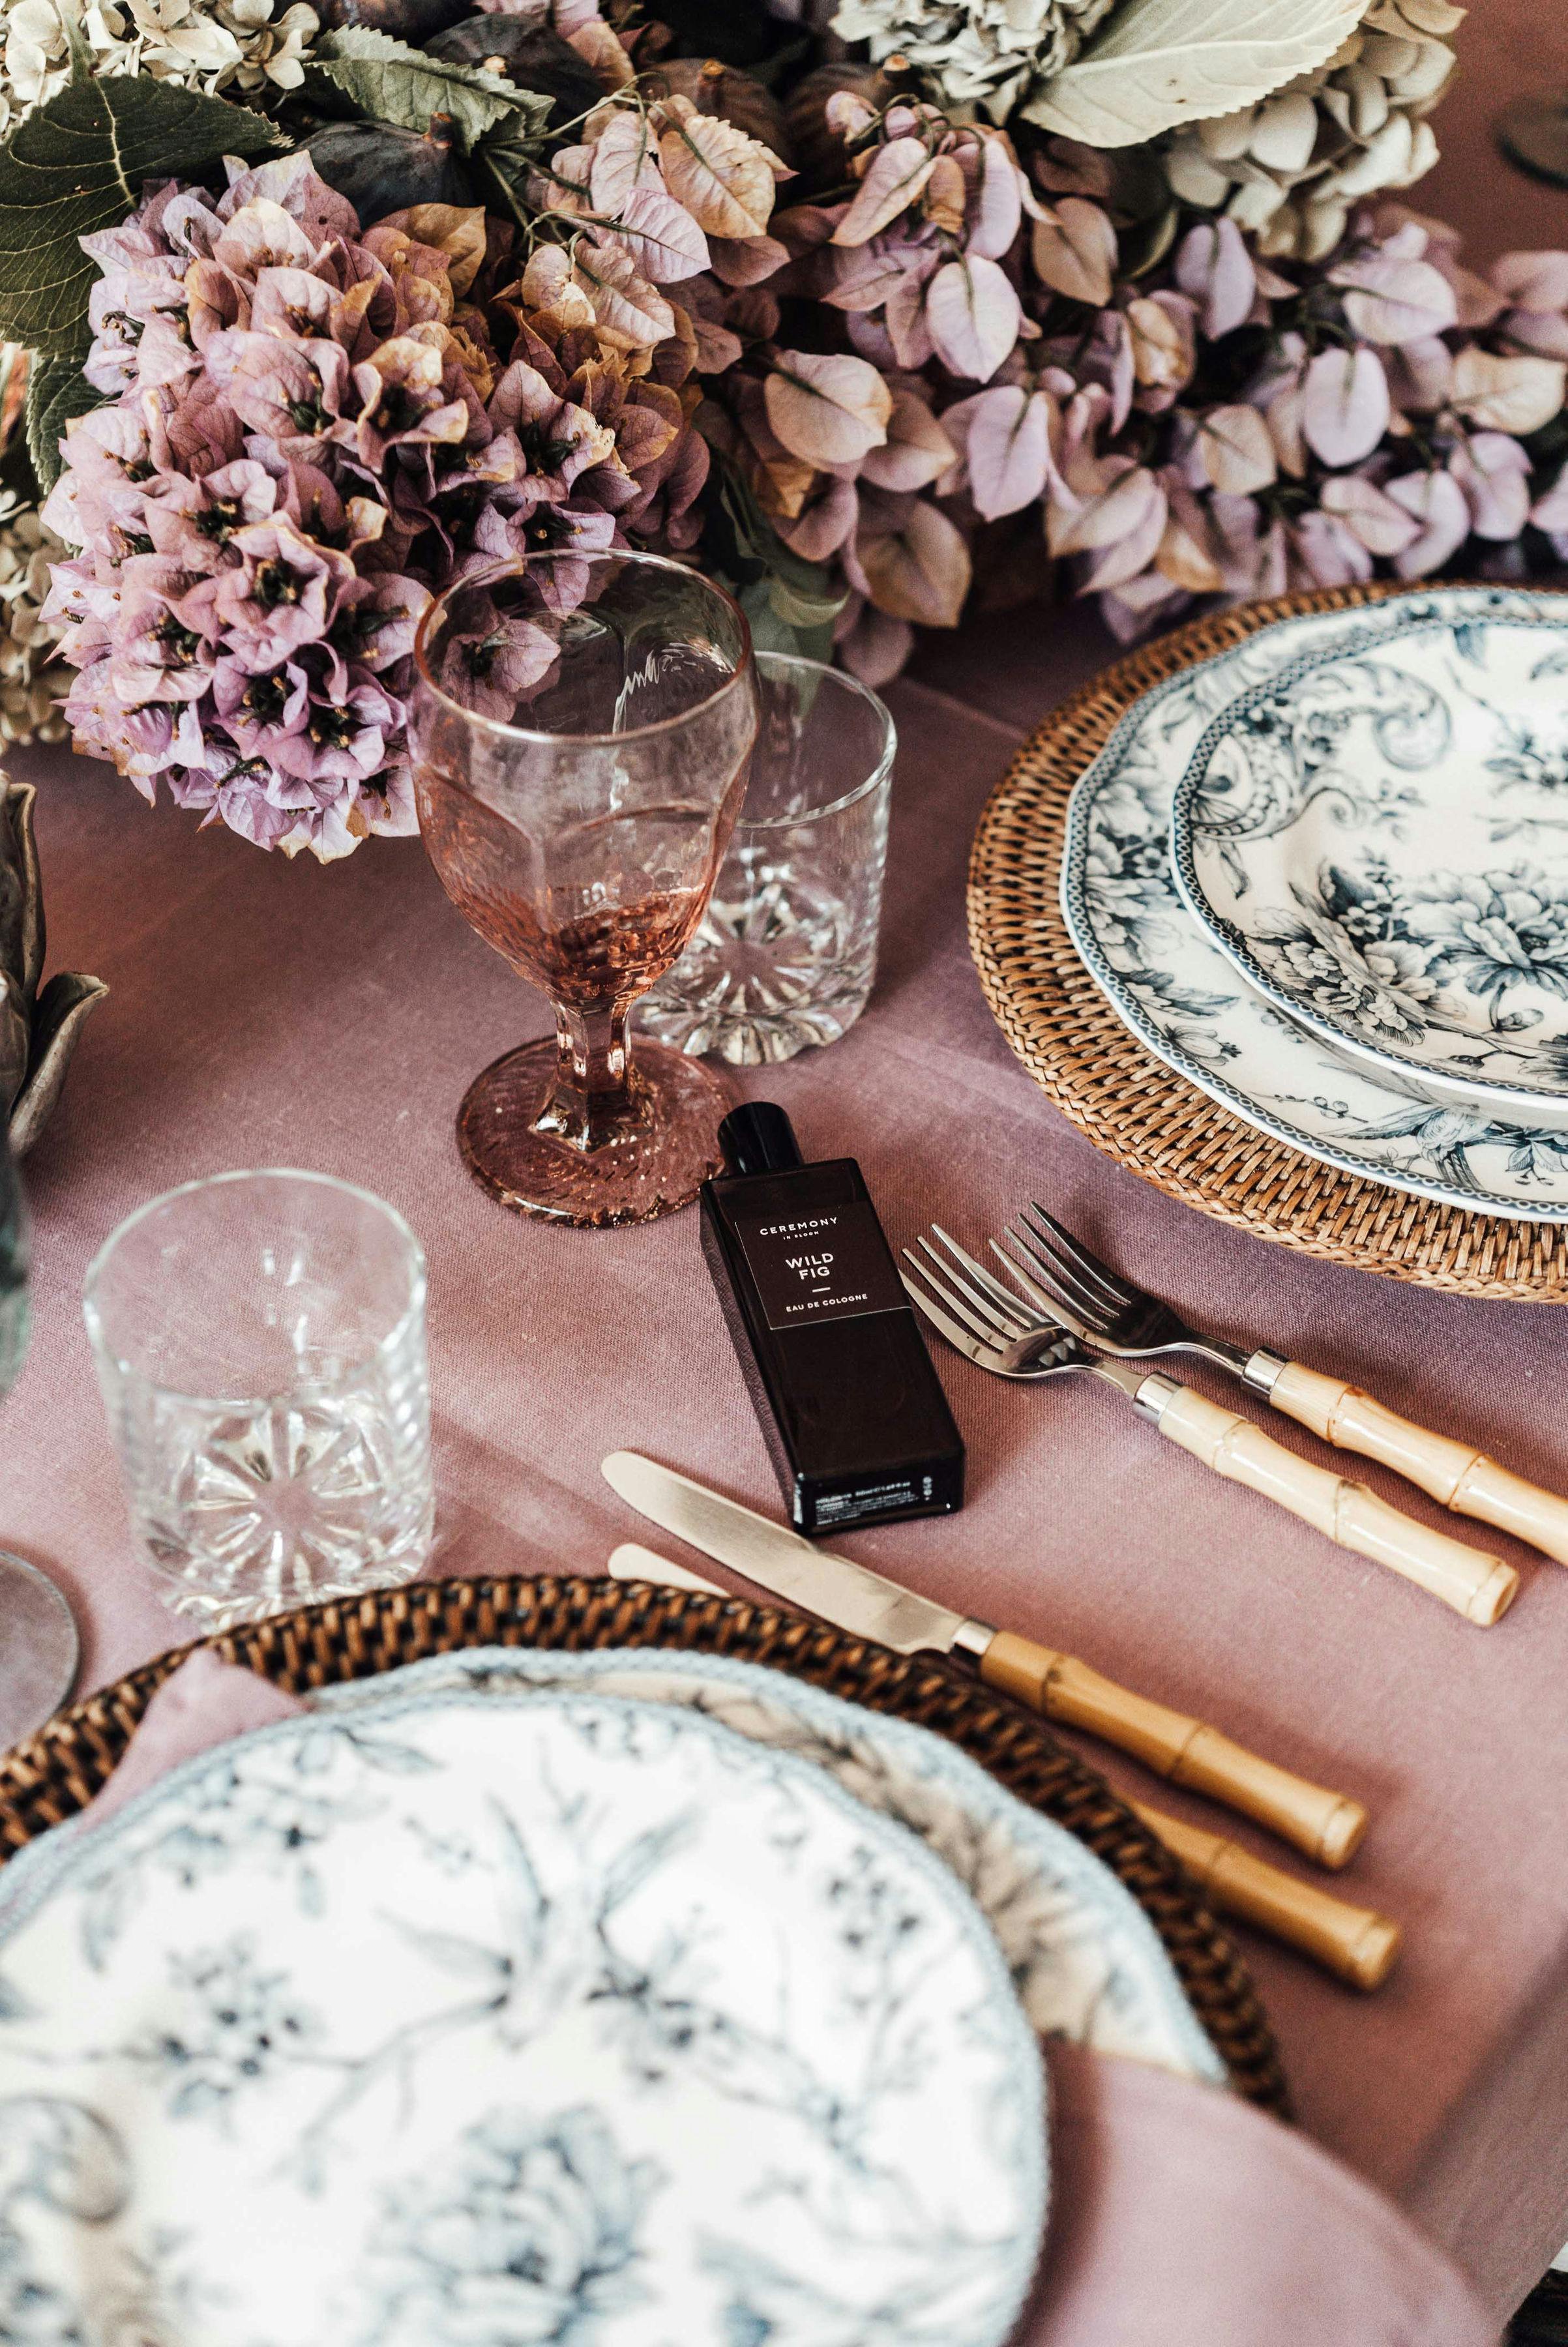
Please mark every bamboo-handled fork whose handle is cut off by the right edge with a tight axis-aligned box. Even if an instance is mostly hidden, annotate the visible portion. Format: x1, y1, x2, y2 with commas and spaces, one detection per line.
990, 1206, 1568, 1565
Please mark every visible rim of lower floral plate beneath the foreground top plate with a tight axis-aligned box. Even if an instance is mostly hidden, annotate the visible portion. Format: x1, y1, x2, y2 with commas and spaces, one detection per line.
303, 1646, 1225, 2086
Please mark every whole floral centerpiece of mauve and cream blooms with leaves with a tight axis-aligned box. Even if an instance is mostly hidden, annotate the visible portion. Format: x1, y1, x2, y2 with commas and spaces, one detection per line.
0, 0, 1568, 857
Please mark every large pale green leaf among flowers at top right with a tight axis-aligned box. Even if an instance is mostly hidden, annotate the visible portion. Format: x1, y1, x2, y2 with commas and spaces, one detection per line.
1024, 0, 1366, 145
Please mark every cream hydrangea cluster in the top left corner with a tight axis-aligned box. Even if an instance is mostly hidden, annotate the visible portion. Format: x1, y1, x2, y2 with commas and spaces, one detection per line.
0, 0, 321, 134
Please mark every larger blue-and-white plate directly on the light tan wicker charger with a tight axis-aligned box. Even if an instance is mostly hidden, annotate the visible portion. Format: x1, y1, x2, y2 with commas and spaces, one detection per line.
1061, 587, 1568, 1223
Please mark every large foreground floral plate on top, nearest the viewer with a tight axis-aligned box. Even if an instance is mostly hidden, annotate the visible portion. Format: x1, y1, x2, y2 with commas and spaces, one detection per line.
0, 1690, 1044, 2347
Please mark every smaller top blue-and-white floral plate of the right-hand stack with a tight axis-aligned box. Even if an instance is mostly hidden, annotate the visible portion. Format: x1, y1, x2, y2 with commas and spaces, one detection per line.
1172, 589, 1568, 1131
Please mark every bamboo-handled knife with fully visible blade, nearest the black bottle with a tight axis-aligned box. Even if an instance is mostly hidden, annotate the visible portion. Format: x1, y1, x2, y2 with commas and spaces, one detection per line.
601, 1451, 1366, 1866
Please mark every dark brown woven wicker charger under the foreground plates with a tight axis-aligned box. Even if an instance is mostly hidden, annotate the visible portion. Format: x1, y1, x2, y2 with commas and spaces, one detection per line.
0, 1577, 1289, 2117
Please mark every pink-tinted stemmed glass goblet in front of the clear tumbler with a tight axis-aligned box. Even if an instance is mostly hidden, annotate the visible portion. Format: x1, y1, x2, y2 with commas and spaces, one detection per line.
411, 552, 756, 1223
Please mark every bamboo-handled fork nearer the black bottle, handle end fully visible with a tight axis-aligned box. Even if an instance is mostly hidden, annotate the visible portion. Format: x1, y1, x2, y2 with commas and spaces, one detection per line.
899, 1223, 1518, 1627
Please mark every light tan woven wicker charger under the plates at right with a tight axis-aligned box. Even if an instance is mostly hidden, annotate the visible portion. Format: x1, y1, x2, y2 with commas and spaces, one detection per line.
969, 584, 1568, 1303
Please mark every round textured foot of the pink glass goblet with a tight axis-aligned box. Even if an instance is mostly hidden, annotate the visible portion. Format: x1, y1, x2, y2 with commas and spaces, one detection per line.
458, 1035, 732, 1225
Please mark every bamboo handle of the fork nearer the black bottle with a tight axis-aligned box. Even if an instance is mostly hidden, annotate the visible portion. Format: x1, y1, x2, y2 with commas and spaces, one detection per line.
1138, 1378, 1518, 1627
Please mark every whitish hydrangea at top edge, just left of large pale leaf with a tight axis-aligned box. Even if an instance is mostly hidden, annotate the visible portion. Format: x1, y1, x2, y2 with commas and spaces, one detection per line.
833, 0, 1115, 122
